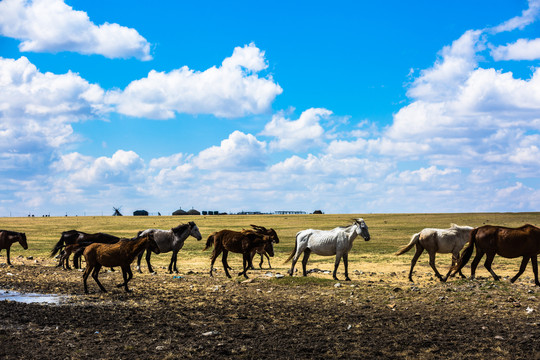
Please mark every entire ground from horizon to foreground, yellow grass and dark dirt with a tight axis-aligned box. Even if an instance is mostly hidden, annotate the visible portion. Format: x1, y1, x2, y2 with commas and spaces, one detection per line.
0, 213, 540, 359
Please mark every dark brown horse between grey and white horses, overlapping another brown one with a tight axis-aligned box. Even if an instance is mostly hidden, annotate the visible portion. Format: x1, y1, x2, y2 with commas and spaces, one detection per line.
203, 230, 272, 279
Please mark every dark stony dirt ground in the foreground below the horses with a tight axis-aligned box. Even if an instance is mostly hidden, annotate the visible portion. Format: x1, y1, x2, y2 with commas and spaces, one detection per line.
0, 259, 540, 359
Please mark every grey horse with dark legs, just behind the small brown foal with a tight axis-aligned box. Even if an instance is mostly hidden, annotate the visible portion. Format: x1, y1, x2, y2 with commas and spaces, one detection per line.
137, 221, 202, 273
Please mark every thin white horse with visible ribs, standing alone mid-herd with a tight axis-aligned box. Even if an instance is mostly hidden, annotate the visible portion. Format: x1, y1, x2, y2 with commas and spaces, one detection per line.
285, 218, 370, 281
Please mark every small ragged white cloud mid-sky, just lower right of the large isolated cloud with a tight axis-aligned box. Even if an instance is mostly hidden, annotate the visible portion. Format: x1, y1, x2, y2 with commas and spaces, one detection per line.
261, 108, 332, 151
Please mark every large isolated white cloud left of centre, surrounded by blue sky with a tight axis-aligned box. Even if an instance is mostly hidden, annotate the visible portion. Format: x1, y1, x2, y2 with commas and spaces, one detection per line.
108, 44, 282, 119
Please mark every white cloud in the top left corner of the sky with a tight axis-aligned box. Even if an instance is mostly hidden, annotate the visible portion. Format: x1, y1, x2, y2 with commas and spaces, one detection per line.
0, 0, 152, 60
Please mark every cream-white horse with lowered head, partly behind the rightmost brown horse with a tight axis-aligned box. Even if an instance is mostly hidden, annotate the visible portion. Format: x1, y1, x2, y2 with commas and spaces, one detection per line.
395, 224, 473, 282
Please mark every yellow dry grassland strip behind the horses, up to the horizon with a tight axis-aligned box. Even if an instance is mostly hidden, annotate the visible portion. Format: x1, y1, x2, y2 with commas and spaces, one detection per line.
0, 213, 540, 276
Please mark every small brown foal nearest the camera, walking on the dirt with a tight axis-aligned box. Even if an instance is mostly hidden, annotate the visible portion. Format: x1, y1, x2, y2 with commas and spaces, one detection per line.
83, 233, 159, 294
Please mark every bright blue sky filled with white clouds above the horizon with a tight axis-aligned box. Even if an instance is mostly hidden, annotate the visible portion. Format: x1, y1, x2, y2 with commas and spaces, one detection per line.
0, 0, 540, 216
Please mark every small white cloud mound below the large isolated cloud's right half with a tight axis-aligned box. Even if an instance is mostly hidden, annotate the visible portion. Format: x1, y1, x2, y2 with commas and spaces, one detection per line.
193, 131, 266, 171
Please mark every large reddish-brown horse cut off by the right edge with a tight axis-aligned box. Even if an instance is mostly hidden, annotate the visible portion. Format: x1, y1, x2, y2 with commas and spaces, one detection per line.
453, 224, 540, 286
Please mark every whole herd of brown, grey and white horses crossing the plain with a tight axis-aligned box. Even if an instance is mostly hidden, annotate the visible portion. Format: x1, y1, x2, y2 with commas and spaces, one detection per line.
0, 218, 540, 293
